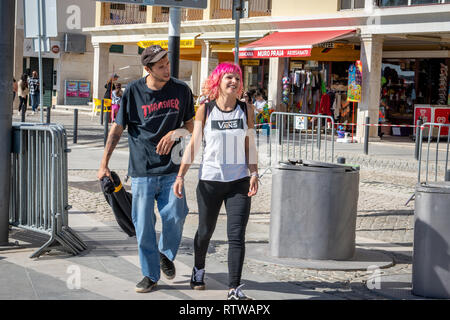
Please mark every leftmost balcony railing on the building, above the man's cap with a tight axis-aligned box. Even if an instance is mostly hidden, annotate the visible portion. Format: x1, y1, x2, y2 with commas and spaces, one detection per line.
103, 3, 147, 25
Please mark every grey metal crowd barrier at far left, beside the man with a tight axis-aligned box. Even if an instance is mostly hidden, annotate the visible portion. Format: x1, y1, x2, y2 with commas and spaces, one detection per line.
9, 123, 87, 258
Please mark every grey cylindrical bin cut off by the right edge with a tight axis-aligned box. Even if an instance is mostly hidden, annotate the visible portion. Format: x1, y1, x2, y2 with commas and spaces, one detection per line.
412, 182, 450, 299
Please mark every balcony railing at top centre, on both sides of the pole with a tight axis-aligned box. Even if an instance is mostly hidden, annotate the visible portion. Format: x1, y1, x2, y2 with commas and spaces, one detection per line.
211, 0, 272, 19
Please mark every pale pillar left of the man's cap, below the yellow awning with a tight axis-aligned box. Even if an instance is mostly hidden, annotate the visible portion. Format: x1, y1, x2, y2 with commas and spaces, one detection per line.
92, 43, 111, 99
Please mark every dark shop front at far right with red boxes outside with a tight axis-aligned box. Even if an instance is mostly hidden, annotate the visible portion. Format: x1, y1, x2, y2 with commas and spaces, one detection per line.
380, 59, 450, 136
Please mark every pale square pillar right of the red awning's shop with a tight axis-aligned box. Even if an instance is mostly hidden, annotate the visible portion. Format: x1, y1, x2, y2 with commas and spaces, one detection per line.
356, 34, 383, 142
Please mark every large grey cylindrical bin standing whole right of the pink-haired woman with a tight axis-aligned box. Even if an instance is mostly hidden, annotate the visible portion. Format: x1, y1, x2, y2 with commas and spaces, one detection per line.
269, 161, 359, 260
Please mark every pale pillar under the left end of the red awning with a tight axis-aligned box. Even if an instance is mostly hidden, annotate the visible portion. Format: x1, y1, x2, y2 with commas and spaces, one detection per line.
267, 58, 285, 111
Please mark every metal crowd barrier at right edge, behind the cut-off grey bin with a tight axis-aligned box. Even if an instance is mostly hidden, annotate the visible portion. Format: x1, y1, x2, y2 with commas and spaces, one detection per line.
417, 122, 450, 184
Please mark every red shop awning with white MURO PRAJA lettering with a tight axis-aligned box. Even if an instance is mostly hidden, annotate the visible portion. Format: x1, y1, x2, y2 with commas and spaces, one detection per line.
239, 29, 356, 59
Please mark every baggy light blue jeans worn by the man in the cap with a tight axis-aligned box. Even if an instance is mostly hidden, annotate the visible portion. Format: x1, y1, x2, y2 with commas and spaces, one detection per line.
131, 173, 189, 282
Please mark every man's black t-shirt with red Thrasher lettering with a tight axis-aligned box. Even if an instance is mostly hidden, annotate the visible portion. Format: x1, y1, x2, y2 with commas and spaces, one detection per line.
115, 77, 195, 177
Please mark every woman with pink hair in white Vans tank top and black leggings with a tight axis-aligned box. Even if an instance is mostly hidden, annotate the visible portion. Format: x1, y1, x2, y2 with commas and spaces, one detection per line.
173, 62, 259, 300
